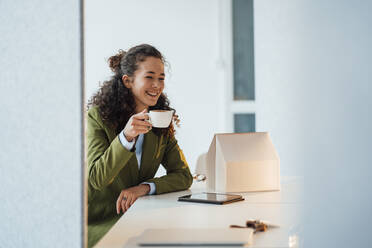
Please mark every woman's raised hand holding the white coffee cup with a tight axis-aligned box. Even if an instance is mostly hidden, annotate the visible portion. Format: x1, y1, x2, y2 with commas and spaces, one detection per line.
124, 109, 152, 142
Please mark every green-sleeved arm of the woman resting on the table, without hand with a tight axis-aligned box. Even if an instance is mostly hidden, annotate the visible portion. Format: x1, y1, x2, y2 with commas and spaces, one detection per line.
146, 137, 193, 194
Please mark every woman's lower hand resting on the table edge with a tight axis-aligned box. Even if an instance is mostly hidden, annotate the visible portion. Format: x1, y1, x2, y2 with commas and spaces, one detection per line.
116, 184, 150, 214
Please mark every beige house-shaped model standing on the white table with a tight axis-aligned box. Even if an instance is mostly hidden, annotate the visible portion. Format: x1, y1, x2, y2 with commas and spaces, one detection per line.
206, 132, 280, 192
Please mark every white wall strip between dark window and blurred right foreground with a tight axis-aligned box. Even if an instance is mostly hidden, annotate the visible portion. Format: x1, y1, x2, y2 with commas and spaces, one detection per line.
254, 0, 306, 175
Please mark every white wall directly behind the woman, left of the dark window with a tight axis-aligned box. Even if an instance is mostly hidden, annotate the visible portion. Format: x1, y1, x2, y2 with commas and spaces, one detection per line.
85, 0, 223, 174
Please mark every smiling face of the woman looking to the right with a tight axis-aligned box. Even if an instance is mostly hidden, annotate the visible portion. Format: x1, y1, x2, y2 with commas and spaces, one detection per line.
122, 57, 165, 113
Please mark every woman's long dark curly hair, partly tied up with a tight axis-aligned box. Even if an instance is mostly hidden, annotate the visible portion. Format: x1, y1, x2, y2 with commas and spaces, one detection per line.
87, 44, 176, 136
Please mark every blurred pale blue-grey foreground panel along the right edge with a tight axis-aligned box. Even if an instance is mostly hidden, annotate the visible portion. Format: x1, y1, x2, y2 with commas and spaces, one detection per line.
300, 0, 372, 247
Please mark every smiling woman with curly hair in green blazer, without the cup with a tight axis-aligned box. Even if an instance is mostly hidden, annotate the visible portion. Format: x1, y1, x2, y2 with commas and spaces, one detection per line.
87, 44, 192, 246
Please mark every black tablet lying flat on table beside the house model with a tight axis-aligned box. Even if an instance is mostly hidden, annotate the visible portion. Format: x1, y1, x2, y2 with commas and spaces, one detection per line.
178, 193, 244, 204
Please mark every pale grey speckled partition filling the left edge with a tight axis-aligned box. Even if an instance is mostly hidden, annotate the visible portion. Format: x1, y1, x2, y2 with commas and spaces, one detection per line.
0, 0, 83, 247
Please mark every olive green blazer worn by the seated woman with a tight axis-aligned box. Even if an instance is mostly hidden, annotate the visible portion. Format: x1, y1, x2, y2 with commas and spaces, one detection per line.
87, 107, 192, 223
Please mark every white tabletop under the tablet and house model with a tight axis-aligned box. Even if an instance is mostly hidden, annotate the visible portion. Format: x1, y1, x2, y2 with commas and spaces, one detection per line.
96, 178, 303, 248
